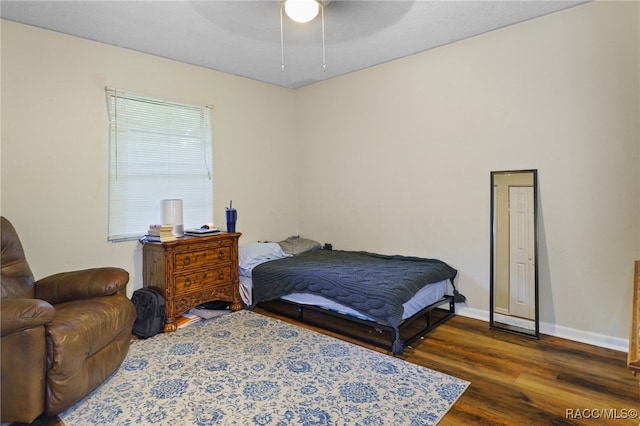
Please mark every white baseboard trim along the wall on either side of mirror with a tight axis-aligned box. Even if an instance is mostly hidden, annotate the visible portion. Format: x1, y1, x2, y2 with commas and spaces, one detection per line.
456, 303, 629, 353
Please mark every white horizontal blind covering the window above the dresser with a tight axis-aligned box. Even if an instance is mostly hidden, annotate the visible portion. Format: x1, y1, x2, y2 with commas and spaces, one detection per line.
105, 87, 213, 241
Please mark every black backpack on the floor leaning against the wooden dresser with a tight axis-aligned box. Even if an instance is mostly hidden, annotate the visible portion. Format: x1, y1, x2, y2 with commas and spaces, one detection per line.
131, 287, 166, 339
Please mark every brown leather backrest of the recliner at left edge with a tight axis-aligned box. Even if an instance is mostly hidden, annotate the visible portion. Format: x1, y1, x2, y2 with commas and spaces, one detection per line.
0, 217, 35, 299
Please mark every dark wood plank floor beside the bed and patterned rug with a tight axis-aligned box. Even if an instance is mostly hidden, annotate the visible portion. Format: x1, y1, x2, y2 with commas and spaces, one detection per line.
255, 309, 640, 426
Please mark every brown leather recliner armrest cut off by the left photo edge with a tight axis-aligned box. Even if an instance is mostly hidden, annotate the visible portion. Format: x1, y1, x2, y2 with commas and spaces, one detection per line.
0, 299, 56, 337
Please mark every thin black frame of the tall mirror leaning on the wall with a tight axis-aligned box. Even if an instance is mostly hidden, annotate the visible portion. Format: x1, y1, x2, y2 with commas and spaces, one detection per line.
489, 169, 540, 339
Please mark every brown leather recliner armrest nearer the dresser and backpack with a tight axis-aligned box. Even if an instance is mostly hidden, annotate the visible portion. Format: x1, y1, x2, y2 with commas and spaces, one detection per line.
35, 267, 129, 305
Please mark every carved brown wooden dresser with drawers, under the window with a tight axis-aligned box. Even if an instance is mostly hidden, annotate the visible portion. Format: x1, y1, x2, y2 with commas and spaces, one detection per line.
142, 232, 242, 332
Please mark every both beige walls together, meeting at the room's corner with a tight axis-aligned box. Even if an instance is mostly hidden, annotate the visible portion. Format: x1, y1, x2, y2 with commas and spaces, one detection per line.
1, 2, 640, 346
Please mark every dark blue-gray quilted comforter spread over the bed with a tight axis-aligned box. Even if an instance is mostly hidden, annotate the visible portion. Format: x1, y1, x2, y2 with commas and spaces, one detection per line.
252, 250, 457, 331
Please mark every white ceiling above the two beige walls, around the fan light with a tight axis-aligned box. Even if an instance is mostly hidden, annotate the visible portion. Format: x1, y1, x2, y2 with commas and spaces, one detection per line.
0, 0, 584, 89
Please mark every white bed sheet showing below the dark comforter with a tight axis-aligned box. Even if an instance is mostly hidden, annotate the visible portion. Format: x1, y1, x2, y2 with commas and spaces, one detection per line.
240, 275, 449, 320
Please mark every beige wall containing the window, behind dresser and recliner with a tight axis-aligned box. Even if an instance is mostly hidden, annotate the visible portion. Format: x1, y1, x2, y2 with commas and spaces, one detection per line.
0, 20, 298, 292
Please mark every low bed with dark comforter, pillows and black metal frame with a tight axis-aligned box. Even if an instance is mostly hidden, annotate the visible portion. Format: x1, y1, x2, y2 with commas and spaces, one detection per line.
239, 237, 463, 354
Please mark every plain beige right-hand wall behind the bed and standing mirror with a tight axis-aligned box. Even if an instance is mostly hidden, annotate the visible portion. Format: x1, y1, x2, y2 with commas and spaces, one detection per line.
296, 2, 640, 345
